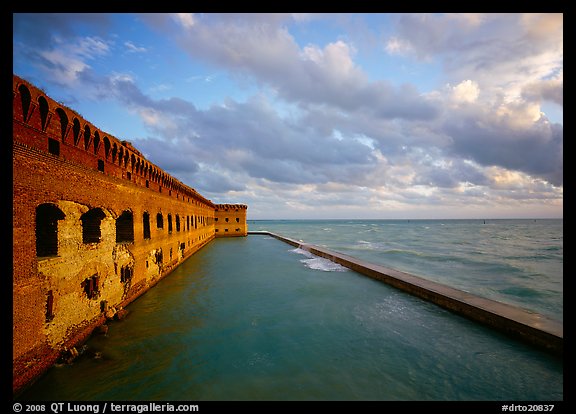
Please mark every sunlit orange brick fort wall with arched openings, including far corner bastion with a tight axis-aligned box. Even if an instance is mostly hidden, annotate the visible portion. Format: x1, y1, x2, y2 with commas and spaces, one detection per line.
12, 75, 248, 392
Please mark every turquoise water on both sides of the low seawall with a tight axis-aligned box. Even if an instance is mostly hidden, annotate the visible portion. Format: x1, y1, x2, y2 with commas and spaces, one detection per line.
19, 220, 563, 401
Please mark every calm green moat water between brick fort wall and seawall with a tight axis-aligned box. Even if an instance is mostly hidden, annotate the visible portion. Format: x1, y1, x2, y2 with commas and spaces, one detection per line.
20, 222, 563, 401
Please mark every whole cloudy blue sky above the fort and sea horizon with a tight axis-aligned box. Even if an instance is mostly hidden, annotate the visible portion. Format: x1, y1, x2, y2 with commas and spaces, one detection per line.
13, 13, 564, 220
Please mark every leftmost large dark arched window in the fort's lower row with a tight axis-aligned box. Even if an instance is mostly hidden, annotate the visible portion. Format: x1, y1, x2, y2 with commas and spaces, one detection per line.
36, 203, 65, 257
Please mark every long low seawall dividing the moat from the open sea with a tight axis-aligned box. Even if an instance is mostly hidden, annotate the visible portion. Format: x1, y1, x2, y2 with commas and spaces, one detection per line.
248, 231, 564, 357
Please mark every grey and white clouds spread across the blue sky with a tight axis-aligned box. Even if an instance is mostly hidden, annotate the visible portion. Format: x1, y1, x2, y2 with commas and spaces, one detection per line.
13, 14, 563, 216
